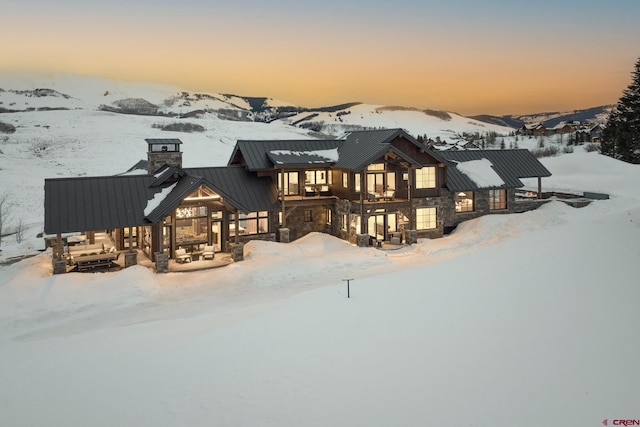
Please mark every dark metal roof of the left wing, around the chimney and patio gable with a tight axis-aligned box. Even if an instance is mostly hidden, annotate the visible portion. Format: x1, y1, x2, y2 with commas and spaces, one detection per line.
44, 167, 280, 234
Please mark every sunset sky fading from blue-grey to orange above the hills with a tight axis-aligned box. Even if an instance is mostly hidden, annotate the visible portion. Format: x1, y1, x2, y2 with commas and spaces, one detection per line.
0, 0, 640, 115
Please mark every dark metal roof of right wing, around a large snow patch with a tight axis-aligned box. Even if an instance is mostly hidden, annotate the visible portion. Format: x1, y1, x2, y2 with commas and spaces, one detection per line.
440, 149, 551, 191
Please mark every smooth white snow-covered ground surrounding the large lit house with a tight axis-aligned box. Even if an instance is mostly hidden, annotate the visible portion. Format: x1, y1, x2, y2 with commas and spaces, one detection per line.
0, 74, 640, 426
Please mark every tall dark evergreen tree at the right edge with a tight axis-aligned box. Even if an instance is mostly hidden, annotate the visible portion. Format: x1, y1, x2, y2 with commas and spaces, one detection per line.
600, 58, 640, 163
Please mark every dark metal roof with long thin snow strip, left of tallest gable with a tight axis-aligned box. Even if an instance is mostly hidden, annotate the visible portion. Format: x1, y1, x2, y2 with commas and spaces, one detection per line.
229, 139, 342, 171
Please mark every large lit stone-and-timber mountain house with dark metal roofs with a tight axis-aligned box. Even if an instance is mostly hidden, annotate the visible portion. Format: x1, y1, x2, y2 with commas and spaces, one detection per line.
45, 129, 551, 273
